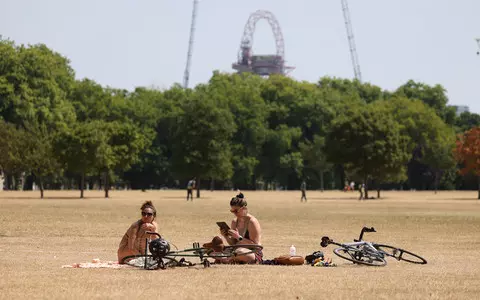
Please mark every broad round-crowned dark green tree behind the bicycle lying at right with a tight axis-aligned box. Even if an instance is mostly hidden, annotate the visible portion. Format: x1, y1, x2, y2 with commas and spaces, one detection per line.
325, 105, 410, 197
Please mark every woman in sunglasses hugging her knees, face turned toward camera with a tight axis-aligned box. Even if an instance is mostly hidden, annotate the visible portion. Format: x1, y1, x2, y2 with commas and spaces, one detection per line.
117, 201, 158, 263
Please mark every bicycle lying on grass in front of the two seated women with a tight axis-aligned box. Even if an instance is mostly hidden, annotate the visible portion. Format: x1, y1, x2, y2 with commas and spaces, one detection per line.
121, 232, 263, 270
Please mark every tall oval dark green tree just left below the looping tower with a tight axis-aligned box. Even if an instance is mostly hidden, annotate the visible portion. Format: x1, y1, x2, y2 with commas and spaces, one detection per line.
172, 86, 235, 198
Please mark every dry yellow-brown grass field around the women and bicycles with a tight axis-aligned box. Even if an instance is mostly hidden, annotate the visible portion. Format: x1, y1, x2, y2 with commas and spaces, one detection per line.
0, 191, 480, 299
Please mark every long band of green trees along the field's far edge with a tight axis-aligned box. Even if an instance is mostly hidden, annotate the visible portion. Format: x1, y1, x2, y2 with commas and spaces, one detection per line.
0, 38, 480, 197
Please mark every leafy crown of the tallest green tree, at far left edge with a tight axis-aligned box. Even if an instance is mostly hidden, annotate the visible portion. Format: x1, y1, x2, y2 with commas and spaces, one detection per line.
0, 40, 75, 127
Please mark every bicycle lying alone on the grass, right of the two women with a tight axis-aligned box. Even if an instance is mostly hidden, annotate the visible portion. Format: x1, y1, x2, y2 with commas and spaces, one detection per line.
320, 227, 427, 267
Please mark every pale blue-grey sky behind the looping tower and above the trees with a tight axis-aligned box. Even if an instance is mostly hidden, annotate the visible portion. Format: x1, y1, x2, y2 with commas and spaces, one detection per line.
0, 0, 480, 113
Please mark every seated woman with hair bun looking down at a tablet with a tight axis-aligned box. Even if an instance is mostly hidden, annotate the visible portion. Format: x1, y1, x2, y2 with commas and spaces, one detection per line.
220, 193, 263, 263
